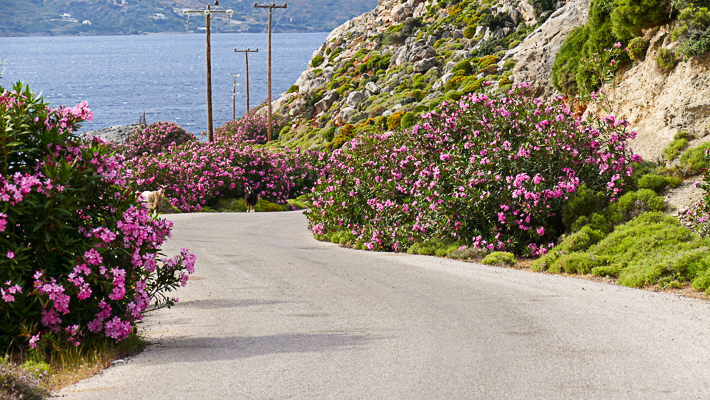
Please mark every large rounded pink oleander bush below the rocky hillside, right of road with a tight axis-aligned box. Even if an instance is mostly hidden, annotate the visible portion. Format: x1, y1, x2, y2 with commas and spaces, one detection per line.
308, 84, 640, 254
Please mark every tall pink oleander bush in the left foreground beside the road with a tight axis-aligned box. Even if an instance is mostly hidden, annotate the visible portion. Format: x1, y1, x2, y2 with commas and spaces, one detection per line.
0, 84, 195, 349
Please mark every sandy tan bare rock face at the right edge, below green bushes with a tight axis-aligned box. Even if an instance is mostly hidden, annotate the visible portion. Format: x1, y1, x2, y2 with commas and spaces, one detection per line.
587, 26, 710, 160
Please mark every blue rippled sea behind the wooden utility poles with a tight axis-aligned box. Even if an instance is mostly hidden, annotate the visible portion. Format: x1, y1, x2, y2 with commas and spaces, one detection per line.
0, 33, 328, 134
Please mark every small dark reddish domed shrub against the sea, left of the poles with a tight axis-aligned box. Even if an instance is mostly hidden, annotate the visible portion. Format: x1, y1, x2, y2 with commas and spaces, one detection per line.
120, 122, 196, 158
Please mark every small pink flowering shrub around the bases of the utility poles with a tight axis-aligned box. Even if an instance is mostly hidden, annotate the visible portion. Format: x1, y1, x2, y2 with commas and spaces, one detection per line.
214, 110, 287, 144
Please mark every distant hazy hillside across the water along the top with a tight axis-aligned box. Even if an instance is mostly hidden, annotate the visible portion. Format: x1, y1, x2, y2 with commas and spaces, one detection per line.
0, 0, 377, 36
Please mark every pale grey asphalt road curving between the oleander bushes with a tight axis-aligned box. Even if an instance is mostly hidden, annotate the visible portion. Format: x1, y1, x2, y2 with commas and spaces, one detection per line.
59, 212, 710, 400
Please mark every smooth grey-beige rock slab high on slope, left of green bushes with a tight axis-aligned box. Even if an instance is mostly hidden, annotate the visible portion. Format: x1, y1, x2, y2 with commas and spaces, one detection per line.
504, 0, 590, 100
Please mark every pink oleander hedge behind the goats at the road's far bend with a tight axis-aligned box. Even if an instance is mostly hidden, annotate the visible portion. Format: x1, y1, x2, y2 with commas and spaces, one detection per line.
127, 115, 318, 211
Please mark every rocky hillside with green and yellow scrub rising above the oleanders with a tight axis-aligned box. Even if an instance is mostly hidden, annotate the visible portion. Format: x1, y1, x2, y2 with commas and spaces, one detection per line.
270, 0, 710, 212
